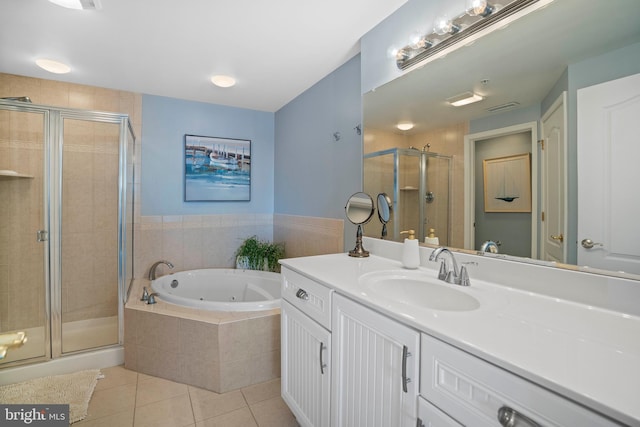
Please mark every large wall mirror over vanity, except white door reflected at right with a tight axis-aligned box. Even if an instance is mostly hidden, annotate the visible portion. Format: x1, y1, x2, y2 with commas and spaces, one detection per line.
363, 0, 640, 278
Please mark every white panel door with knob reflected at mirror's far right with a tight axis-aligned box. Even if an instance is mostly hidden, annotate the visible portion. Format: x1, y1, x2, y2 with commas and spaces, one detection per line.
577, 74, 640, 274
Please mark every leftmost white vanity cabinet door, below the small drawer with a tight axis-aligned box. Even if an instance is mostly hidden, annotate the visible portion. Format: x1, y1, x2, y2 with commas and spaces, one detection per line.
281, 300, 331, 427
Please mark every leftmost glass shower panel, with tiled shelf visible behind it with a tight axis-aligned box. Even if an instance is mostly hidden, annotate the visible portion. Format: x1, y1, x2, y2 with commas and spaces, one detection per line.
0, 105, 49, 366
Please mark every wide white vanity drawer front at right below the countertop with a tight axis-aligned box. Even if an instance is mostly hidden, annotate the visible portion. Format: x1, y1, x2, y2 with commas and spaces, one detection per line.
420, 334, 618, 426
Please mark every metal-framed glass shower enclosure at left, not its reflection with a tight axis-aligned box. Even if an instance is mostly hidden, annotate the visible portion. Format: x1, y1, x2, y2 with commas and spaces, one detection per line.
0, 100, 135, 369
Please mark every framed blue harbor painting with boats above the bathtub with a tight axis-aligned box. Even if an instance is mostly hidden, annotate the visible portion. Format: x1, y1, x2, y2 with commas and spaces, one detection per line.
184, 135, 251, 202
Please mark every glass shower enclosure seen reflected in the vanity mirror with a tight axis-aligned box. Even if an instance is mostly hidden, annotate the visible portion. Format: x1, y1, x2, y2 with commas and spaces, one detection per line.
363, 148, 453, 245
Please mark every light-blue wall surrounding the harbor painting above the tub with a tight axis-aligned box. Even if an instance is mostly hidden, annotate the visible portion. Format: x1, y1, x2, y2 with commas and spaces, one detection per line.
140, 95, 274, 215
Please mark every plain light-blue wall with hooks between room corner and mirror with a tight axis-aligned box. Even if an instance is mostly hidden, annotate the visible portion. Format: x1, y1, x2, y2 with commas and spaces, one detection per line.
275, 55, 362, 247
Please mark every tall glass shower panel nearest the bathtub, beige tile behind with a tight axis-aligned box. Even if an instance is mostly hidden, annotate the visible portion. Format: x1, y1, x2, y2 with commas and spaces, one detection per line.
57, 112, 121, 356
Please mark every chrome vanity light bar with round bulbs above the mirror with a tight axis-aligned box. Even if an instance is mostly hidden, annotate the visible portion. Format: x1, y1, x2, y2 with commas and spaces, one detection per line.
395, 0, 540, 70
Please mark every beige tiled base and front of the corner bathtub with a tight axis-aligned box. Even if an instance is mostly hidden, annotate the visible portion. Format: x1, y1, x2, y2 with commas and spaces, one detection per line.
124, 279, 280, 393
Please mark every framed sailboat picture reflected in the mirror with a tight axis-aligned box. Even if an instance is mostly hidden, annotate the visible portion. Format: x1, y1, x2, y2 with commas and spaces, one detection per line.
482, 153, 531, 212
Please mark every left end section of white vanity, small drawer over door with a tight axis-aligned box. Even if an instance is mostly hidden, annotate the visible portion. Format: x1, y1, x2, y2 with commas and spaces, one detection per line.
280, 268, 333, 427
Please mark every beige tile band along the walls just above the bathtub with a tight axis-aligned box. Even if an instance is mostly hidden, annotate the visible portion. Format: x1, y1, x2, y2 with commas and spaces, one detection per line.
135, 214, 344, 278
